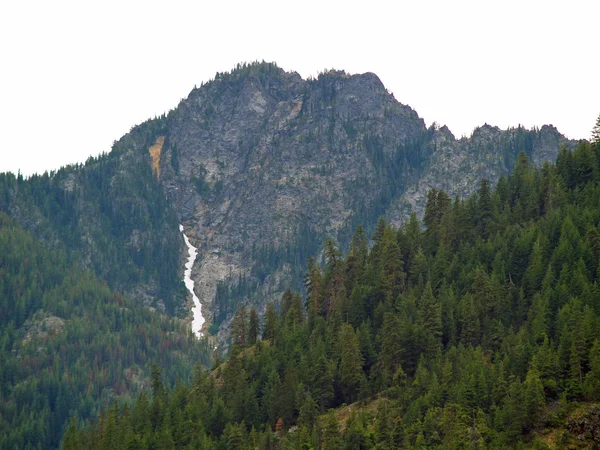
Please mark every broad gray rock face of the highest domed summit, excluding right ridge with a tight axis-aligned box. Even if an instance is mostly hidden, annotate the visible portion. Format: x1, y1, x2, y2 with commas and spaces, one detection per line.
155, 64, 426, 332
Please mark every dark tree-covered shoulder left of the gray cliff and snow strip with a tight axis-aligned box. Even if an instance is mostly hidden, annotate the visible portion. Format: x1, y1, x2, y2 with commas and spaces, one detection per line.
0, 116, 186, 315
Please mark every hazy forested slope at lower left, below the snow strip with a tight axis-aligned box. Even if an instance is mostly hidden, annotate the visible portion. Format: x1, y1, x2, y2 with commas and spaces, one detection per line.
0, 212, 210, 450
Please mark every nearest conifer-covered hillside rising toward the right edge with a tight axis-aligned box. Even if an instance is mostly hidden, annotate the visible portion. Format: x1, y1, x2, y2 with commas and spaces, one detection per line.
64, 139, 600, 449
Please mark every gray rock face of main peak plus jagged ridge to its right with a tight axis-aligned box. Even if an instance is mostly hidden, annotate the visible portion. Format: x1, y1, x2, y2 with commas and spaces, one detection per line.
151, 64, 573, 334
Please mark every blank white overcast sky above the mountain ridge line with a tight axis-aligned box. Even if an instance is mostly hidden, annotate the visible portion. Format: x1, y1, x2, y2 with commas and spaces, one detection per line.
0, 0, 600, 175
